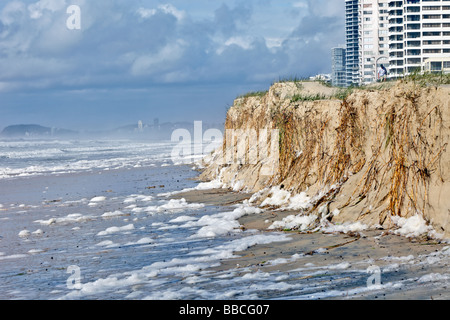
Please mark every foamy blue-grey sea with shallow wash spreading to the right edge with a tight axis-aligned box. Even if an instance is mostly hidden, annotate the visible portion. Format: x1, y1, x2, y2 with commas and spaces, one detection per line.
0, 139, 450, 300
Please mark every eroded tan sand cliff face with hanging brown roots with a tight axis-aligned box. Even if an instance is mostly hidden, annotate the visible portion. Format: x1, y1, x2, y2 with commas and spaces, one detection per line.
201, 82, 450, 238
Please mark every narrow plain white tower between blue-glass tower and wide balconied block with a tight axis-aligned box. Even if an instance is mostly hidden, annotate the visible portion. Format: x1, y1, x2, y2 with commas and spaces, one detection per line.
358, 0, 389, 85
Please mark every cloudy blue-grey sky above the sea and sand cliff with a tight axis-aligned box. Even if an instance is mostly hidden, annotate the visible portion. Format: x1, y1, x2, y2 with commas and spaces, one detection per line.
0, 0, 345, 130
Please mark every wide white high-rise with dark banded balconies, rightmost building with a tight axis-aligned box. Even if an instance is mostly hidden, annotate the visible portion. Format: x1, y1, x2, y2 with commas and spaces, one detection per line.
388, 0, 450, 78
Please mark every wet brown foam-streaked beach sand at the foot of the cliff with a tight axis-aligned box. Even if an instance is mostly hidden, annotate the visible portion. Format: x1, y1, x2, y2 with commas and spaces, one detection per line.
173, 189, 450, 300
